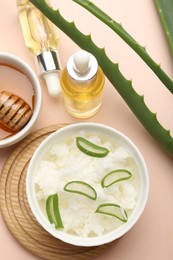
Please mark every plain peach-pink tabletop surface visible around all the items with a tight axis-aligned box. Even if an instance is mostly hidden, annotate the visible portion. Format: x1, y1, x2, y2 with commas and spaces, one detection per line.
0, 0, 173, 260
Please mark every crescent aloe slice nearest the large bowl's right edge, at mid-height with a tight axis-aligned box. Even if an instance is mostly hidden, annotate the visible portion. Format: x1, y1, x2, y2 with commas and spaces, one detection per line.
101, 169, 132, 188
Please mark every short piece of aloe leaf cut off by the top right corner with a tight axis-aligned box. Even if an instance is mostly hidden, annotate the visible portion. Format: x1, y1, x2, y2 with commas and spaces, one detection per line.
155, 0, 173, 56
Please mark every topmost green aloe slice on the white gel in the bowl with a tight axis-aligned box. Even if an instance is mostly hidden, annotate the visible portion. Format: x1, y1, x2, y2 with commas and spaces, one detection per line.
76, 137, 109, 158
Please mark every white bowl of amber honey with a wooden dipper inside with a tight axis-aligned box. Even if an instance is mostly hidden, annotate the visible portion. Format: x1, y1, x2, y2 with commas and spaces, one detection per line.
0, 52, 42, 148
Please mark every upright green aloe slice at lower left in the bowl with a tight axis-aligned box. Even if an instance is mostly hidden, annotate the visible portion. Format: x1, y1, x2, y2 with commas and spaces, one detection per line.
46, 193, 64, 229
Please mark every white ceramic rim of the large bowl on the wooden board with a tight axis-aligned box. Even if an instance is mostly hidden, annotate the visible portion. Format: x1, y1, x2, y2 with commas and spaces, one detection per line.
26, 123, 149, 246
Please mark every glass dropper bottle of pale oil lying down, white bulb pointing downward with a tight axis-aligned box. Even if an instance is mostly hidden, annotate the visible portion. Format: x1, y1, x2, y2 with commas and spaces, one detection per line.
17, 0, 61, 96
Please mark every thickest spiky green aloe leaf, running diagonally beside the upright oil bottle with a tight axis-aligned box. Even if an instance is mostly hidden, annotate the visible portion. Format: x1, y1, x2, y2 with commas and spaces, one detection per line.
30, 0, 173, 157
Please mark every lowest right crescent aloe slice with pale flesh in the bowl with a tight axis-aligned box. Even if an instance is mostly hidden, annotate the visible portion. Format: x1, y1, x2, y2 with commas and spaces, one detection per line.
95, 203, 128, 222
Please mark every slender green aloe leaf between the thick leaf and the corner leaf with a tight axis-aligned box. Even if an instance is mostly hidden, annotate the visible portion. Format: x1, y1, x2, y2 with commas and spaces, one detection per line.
73, 0, 173, 93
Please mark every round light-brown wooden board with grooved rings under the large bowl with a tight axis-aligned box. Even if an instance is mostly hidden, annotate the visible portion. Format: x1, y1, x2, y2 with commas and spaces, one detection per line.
0, 125, 111, 260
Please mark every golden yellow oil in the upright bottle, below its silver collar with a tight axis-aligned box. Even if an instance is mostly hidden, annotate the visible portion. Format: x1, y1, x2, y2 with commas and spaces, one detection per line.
61, 68, 105, 118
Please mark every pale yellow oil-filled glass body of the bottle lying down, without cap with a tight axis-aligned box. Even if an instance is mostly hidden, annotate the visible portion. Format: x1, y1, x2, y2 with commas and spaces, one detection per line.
17, 0, 59, 55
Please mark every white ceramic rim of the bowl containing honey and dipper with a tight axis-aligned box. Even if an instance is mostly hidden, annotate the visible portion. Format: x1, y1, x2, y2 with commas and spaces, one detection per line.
0, 52, 42, 148
